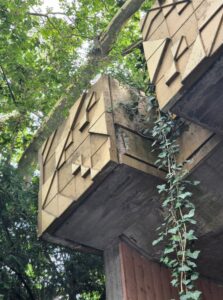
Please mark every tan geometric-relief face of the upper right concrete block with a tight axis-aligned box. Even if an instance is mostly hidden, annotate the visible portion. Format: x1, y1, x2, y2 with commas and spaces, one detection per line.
141, 0, 223, 110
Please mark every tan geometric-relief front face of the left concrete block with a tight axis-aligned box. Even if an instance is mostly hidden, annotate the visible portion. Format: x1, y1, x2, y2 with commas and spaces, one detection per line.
39, 81, 115, 233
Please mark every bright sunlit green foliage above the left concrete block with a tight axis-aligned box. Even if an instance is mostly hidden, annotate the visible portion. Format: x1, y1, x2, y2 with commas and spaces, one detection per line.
0, 0, 151, 161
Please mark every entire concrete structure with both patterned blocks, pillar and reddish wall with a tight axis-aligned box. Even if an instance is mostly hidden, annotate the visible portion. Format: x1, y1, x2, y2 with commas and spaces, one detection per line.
39, 0, 223, 300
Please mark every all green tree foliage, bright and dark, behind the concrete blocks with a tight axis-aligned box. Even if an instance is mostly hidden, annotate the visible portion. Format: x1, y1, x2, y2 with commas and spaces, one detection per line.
0, 0, 152, 300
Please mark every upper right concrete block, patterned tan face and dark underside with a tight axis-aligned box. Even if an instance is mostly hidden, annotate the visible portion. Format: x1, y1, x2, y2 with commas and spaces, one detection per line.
141, 0, 223, 134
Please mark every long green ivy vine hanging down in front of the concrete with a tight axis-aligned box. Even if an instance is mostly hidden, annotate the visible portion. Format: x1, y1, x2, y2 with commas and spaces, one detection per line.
152, 112, 201, 300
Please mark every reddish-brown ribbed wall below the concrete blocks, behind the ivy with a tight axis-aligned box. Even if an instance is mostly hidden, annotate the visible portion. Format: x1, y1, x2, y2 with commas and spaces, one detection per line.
120, 242, 223, 300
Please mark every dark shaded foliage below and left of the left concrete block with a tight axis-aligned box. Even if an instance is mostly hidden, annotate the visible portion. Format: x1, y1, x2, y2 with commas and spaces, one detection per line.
0, 165, 104, 300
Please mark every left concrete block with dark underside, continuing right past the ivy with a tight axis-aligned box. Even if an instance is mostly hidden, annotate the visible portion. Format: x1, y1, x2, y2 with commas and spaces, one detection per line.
40, 78, 223, 284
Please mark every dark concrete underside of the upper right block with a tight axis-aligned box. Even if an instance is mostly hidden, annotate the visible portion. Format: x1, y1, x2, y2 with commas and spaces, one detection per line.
171, 53, 223, 134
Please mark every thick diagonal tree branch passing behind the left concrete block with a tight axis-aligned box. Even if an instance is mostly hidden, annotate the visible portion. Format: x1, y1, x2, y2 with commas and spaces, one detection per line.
19, 0, 144, 175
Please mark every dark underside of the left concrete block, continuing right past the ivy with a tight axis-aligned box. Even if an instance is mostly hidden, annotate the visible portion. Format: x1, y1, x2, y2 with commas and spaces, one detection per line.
44, 144, 223, 282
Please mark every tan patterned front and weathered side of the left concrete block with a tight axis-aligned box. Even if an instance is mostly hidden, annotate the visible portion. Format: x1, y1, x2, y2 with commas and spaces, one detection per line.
38, 75, 169, 236
